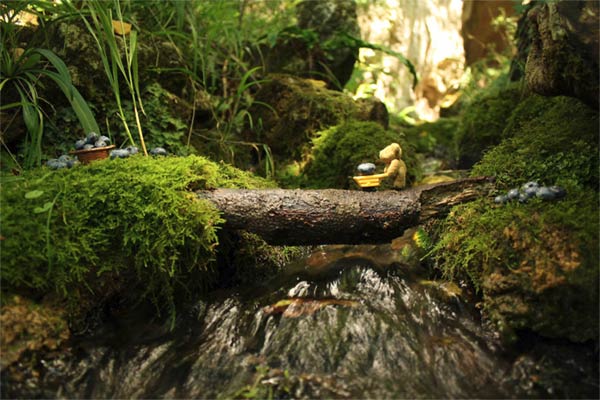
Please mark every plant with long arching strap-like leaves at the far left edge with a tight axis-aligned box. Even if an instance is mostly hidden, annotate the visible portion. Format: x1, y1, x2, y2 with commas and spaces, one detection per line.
0, 2, 99, 168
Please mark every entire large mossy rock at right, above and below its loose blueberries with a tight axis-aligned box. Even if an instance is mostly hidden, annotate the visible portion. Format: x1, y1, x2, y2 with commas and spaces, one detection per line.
436, 96, 599, 342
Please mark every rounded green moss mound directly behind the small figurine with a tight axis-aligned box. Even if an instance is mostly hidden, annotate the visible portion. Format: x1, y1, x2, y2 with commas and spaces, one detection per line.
303, 121, 418, 189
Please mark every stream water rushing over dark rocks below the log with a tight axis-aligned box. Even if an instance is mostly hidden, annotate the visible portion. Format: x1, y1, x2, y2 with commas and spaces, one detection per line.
16, 245, 597, 398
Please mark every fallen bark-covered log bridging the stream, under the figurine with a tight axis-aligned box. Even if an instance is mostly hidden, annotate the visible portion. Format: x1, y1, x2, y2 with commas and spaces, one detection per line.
197, 177, 492, 245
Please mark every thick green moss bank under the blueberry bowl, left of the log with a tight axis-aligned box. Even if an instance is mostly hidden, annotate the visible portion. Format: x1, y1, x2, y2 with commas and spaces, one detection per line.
0, 156, 272, 318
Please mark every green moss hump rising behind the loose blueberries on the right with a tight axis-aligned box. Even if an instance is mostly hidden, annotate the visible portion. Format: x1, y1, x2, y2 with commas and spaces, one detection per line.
473, 96, 599, 189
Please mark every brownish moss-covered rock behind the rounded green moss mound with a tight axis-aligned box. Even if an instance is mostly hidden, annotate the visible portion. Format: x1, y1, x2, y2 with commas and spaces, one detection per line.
245, 74, 388, 161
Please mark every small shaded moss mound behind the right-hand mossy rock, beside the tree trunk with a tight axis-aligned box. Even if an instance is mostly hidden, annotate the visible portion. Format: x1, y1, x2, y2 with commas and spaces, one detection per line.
455, 84, 522, 168
